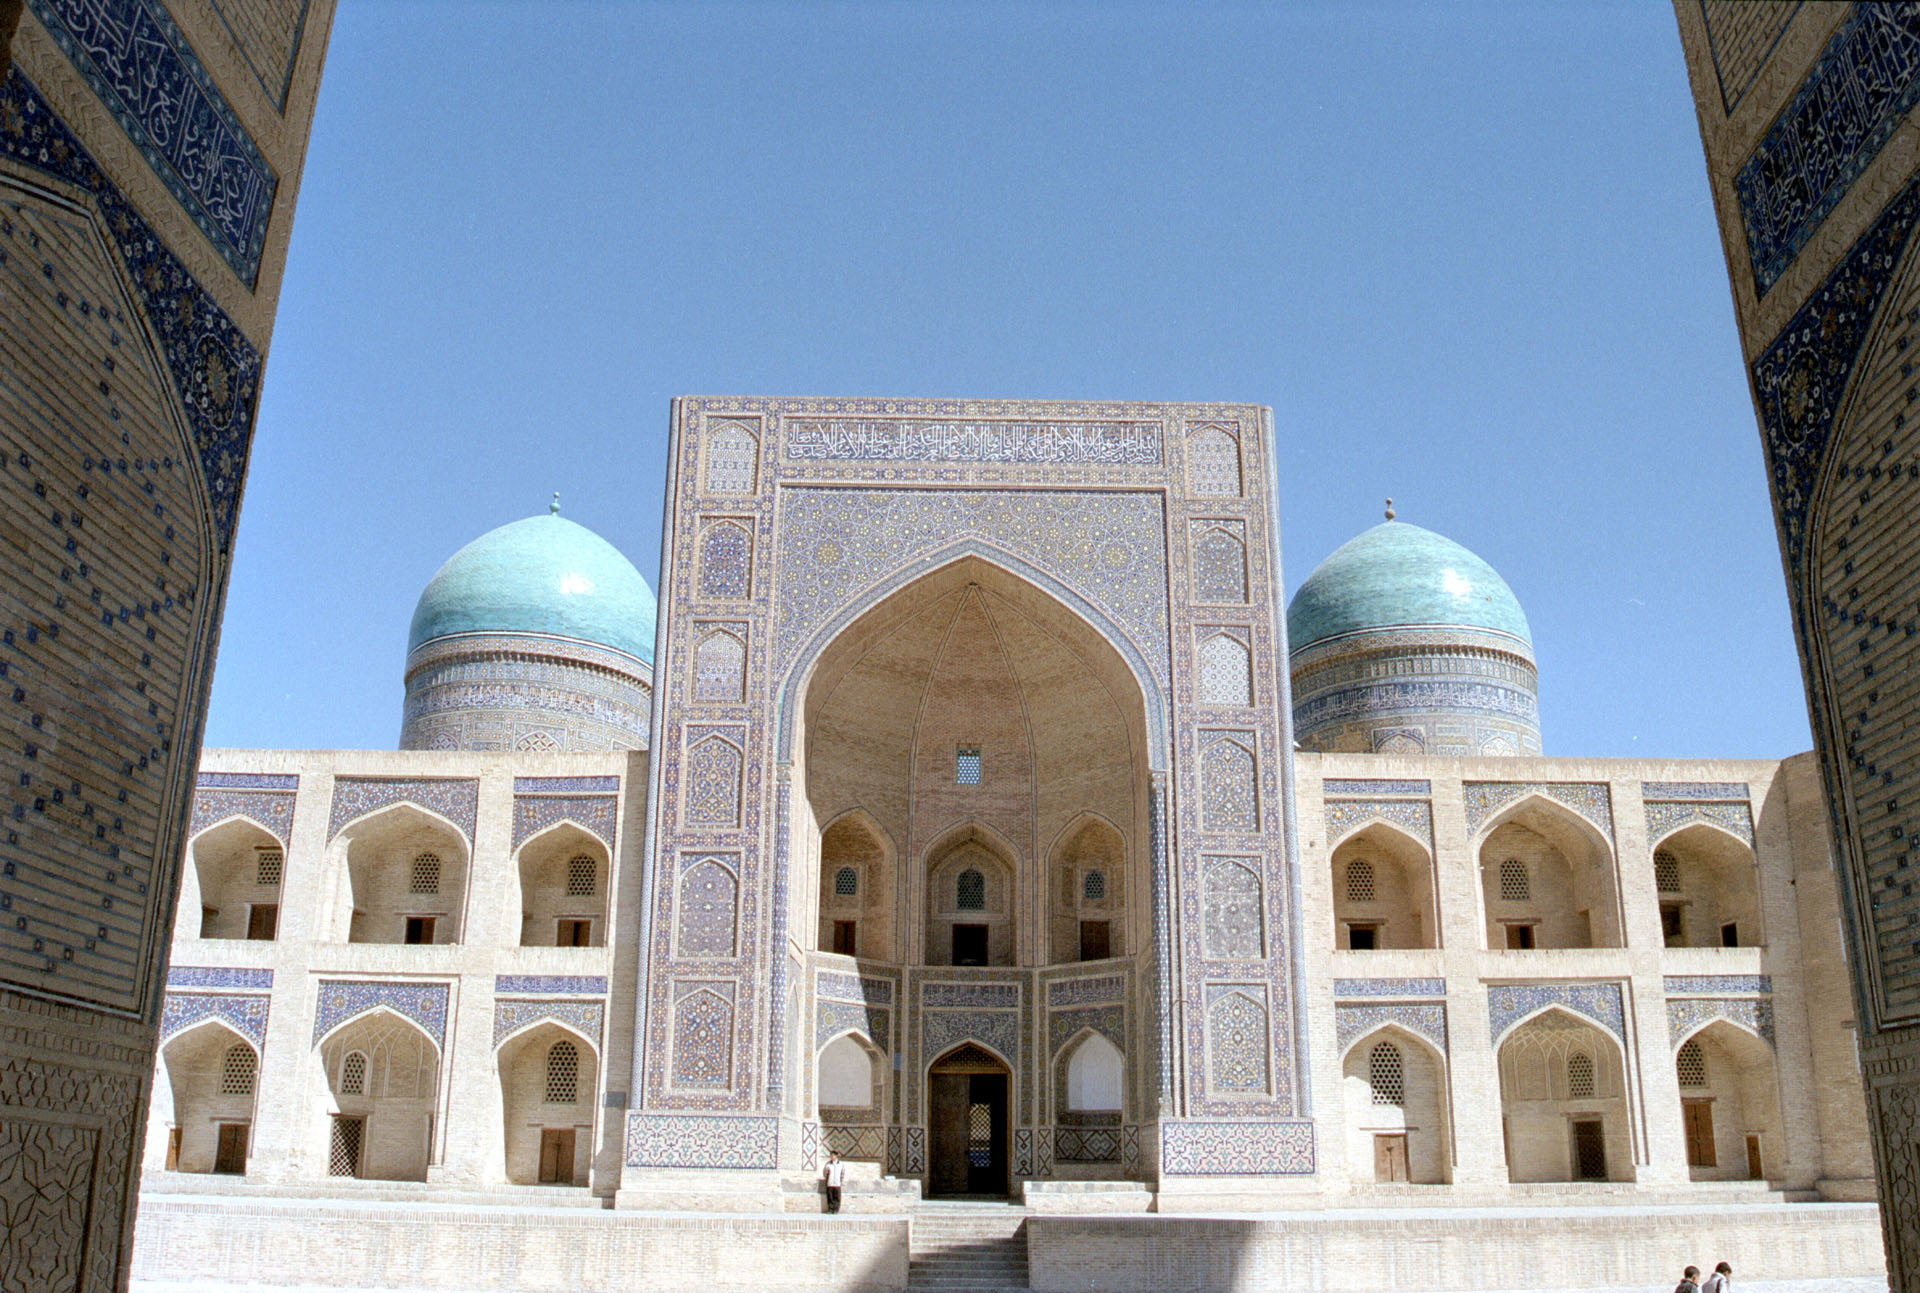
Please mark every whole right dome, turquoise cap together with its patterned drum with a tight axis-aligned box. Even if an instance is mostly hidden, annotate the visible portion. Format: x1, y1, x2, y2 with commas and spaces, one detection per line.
1286, 521, 1540, 755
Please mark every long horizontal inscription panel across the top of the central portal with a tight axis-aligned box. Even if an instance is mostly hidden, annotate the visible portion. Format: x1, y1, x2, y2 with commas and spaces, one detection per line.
785, 417, 1162, 467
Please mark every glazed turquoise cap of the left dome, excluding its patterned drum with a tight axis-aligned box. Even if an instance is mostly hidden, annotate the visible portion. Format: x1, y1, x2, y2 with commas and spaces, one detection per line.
407, 513, 657, 665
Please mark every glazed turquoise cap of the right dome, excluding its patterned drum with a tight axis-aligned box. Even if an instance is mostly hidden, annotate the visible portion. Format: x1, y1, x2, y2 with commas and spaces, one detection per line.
1286, 521, 1532, 651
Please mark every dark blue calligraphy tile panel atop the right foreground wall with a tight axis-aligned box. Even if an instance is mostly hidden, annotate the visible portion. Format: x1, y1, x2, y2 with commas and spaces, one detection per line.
1734, 0, 1920, 296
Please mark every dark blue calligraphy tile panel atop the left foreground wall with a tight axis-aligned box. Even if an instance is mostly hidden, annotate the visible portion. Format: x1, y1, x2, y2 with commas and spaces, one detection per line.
29, 0, 280, 286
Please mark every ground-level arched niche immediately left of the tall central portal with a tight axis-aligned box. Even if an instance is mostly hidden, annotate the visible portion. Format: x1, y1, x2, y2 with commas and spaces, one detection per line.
495, 1020, 599, 1185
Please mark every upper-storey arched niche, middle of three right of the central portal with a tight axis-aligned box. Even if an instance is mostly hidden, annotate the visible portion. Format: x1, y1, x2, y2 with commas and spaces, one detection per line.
1480, 795, 1624, 949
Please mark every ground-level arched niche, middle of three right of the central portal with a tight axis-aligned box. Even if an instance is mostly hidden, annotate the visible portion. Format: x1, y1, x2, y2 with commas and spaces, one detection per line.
1498, 1007, 1634, 1182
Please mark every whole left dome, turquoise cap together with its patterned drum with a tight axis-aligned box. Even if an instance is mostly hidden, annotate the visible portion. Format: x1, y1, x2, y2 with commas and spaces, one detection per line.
399, 513, 657, 749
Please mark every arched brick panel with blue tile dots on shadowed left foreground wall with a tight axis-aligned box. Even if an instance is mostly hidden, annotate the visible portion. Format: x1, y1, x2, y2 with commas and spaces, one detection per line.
0, 170, 219, 1009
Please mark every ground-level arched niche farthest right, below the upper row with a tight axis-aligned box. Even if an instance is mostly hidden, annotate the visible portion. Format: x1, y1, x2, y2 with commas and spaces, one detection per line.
1674, 1018, 1786, 1182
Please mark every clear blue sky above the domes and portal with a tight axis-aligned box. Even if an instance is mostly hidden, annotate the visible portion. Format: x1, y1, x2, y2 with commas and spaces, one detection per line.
207, 0, 1809, 757
